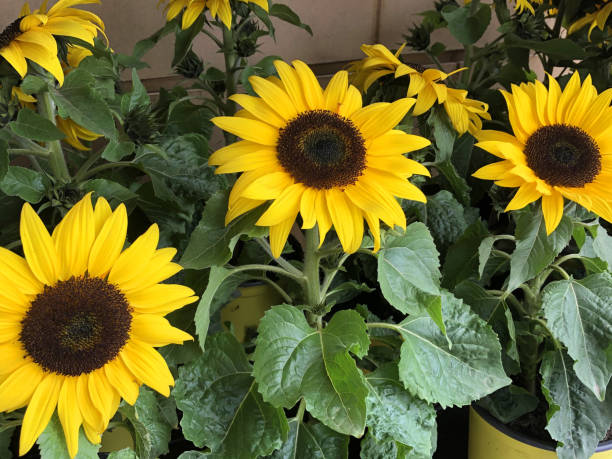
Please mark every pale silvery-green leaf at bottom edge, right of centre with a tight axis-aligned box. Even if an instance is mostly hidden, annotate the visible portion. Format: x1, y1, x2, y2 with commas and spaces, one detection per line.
366, 364, 436, 457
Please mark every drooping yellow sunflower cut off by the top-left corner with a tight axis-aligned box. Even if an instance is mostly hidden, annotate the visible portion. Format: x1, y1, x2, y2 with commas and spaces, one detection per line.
0, 0, 104, 85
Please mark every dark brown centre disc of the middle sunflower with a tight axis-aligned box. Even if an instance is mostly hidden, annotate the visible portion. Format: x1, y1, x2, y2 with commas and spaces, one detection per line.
277, 110, 366, 189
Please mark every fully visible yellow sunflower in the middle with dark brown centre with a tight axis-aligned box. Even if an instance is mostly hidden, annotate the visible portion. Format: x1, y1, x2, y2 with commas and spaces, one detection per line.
209, 61, 430, 256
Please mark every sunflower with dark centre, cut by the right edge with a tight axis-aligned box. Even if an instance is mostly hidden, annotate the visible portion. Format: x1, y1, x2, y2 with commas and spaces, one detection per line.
474, 72, 612, 234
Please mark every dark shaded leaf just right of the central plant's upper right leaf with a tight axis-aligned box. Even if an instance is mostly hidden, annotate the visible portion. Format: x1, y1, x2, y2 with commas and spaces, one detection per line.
442, 220, 489, 289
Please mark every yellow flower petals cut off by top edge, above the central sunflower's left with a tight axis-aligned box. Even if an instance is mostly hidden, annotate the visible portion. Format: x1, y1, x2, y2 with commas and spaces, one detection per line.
158, 0, 268, 29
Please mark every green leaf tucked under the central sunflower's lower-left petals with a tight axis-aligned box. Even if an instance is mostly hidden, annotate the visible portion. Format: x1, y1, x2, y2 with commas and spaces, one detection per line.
181, 190, 263, 269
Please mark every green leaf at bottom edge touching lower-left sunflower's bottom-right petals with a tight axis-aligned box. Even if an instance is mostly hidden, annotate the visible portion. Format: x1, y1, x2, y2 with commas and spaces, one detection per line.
119, 386, 177, 459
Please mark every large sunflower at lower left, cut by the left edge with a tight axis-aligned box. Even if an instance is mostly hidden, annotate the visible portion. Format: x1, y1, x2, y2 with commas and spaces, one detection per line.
0, 195, 196, 457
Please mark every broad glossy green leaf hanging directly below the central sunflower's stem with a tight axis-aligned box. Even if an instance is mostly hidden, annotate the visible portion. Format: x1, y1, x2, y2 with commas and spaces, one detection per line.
253, 305, 370, 437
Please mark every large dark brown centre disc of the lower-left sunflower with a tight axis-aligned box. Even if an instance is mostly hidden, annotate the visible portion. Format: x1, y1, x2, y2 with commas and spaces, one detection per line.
19, 277, 132, 376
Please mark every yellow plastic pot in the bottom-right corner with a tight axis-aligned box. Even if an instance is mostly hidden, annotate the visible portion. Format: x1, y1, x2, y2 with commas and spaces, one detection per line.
468, 407, 612, 459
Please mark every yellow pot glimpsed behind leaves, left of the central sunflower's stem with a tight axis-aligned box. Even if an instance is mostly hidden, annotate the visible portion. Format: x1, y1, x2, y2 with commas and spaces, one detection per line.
221, 282, 283, 342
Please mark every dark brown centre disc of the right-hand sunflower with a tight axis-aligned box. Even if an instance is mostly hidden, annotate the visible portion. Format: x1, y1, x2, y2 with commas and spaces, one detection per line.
525, 124, 601, 188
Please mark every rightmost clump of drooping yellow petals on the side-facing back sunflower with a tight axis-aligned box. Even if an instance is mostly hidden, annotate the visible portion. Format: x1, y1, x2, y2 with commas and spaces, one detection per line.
444, 88, 491, 136
